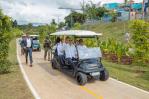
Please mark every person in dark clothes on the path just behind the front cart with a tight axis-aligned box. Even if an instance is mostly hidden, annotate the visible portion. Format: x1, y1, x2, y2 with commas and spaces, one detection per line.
43, 37, 51, 61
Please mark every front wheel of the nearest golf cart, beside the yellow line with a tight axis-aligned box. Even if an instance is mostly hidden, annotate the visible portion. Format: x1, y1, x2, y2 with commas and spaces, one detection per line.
76, 72, 87, 85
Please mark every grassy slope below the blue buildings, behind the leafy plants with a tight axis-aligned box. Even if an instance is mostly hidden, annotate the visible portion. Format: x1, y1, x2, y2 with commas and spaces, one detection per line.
82, 22, 129, 41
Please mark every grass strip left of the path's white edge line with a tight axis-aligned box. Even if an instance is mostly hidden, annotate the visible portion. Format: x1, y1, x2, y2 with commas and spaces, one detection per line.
0, 39, 34, 99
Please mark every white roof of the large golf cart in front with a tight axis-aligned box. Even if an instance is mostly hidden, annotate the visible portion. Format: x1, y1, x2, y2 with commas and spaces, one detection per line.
51, 30, 102, 37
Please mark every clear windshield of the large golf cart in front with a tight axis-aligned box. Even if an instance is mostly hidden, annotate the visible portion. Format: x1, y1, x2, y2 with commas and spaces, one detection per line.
78, 47, 102, 60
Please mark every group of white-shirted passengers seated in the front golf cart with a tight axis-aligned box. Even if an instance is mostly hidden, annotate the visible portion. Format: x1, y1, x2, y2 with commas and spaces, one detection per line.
54, 37, 86, 69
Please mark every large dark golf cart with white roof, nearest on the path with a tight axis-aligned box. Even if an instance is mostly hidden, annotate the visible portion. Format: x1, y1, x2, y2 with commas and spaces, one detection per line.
51, 30, 109, 85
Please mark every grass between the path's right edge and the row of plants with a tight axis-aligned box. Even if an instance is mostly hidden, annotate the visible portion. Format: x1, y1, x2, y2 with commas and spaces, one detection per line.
103, 61, 149, 91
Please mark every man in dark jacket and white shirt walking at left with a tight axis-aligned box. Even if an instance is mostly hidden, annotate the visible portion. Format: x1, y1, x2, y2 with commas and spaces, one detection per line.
24, 34, 33, 67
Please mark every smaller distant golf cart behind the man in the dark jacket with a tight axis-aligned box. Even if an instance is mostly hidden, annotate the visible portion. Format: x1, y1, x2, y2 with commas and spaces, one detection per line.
30, 35, 41, 51
